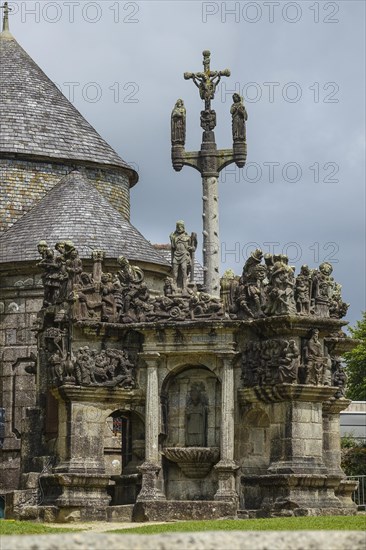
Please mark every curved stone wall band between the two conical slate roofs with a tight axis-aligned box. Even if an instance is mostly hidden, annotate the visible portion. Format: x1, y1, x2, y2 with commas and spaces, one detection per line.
0, 158, 130, 232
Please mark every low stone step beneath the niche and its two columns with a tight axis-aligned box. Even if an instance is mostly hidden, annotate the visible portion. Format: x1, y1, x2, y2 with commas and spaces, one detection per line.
132, 500, 237, 522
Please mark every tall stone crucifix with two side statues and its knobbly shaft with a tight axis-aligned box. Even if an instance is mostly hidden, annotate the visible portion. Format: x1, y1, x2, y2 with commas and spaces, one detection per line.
171, 50, 247, 296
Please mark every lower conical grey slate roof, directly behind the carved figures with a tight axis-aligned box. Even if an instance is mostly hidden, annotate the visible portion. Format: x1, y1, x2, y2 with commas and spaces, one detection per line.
0, 170, 170, 266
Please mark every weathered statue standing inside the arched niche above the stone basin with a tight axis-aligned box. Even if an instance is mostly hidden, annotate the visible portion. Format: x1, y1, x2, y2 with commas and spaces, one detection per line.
185, 382, 208, 447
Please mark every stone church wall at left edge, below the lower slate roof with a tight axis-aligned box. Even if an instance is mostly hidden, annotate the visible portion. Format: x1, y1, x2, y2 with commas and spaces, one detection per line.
0, 273, 43, 491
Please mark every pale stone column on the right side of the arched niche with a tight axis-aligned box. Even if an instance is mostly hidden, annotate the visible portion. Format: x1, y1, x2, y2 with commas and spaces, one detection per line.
215, 352, 238, 502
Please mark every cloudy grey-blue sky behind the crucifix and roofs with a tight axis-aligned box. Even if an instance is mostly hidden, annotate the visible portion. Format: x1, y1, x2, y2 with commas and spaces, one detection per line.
9, 0, 365, 324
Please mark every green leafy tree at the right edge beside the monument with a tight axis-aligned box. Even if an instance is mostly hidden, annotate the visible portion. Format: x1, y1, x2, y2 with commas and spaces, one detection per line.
344, 311, 366, 401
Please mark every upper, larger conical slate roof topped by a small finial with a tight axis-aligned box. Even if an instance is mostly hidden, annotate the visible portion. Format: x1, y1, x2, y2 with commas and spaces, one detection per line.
0, 31, 137, 179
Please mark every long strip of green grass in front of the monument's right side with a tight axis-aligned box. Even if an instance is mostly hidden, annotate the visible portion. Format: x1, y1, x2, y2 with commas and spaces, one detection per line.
109, 516, 366, 535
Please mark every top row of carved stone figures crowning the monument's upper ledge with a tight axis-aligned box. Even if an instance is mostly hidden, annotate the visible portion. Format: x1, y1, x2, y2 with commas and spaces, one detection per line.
38, 242, 348, 324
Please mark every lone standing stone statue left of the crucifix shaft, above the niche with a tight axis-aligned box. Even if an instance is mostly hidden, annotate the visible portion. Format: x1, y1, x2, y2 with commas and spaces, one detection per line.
170, 220, 197, 296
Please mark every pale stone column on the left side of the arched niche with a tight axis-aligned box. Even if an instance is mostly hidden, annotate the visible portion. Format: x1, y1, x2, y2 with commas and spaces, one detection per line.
137, 352, 165, 502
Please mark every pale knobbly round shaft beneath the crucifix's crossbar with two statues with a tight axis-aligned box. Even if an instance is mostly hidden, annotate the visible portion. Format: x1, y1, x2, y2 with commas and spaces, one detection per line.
202, 176, 220, 296
